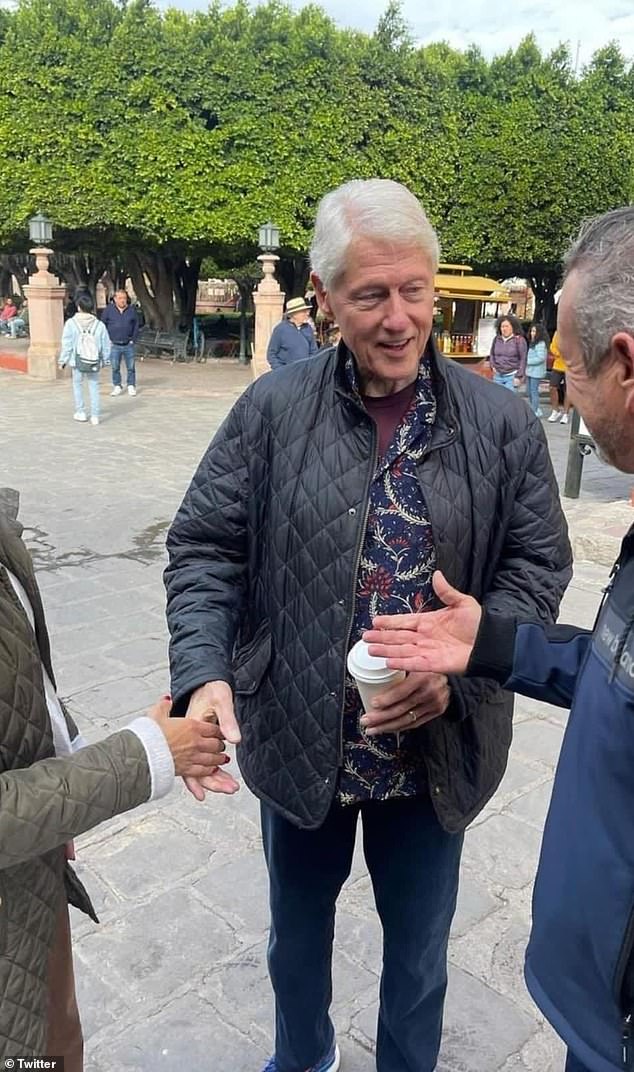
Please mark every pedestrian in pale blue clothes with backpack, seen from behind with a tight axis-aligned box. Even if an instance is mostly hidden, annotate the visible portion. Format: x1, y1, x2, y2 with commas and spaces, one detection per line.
59, 291, 110, 425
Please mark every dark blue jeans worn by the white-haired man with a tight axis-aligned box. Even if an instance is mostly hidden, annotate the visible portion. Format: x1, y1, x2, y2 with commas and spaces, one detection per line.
261, 796, 462, 1072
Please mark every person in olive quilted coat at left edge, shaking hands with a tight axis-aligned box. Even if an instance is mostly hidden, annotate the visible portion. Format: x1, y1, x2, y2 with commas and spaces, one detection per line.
0, 489, 226, 1072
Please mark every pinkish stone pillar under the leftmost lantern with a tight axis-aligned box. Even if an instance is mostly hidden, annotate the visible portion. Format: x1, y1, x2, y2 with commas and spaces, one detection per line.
25, 248, 65, 379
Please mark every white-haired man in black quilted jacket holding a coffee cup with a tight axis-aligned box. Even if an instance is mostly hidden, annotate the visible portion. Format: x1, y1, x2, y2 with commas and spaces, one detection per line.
166, 179, 571, 1072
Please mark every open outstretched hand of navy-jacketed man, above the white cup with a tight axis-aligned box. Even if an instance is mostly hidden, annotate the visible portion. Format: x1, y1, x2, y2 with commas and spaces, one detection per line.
364, 570, 482, 673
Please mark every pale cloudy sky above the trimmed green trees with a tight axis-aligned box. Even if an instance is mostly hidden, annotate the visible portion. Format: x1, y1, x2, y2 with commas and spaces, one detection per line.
168, 0, 634, 64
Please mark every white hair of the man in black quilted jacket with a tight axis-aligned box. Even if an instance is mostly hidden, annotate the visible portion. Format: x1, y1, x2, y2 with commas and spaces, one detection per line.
310, 179, 440, 289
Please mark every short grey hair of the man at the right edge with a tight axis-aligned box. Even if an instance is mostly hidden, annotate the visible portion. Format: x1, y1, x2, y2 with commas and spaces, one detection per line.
565, 205, 634, 376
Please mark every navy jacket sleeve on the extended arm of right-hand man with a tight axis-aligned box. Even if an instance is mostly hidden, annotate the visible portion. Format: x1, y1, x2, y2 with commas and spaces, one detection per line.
467, 610, 592, 708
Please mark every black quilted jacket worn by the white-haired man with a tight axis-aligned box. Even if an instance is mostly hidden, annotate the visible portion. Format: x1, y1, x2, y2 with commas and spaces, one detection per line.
165, 348, 571, 831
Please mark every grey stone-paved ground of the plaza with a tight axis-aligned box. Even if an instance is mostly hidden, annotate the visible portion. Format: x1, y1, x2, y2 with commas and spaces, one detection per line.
0, 361, 630, 1072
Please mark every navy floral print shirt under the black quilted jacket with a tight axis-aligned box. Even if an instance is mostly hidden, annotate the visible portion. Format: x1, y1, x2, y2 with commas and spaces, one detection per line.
338, 356, 436, 804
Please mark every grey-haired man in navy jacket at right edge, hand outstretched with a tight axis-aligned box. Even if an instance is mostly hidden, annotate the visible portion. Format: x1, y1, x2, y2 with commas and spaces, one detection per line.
365, 206, 634, 1072
